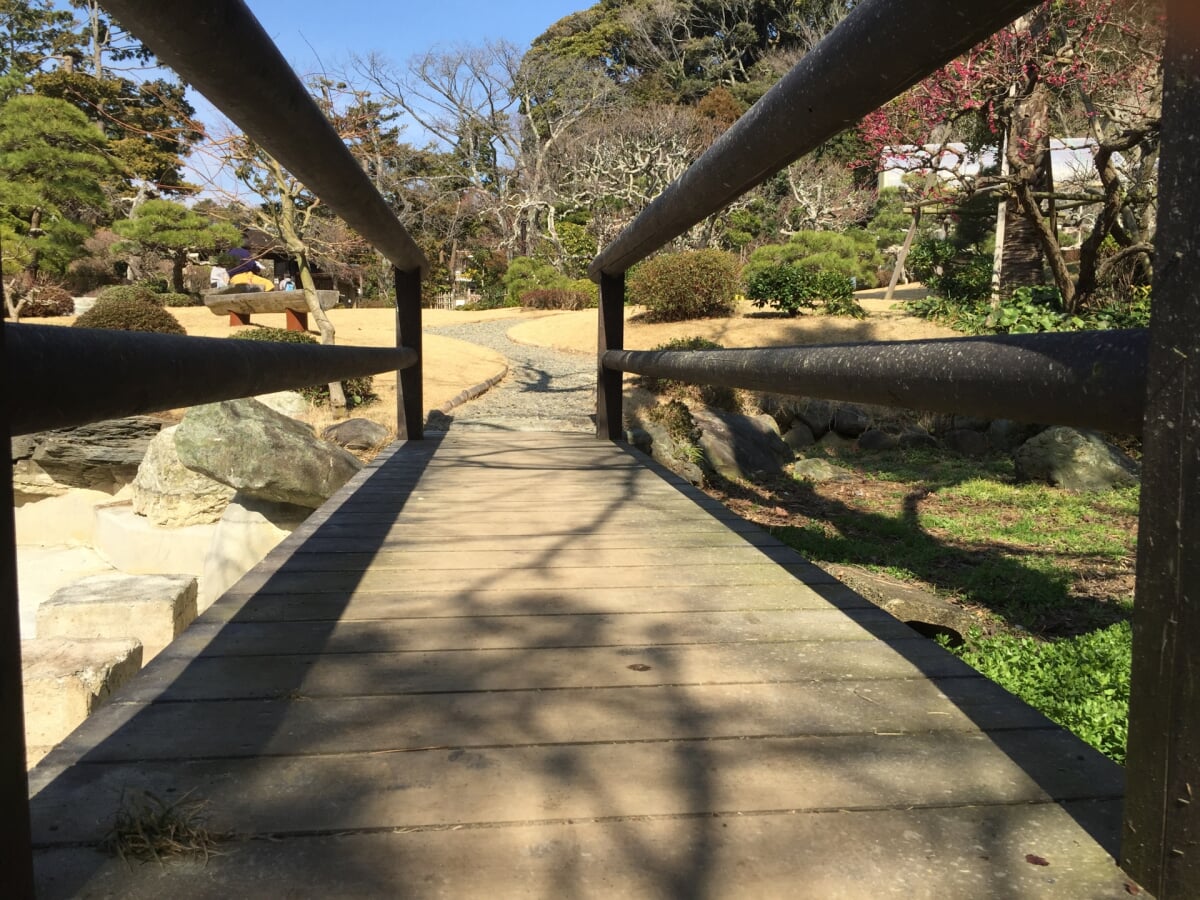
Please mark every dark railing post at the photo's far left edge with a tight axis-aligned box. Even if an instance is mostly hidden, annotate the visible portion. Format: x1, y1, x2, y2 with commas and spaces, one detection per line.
0, 316, 34, 898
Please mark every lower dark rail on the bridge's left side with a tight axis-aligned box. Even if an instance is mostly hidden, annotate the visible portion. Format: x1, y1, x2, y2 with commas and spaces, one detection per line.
4, 325, 418, 434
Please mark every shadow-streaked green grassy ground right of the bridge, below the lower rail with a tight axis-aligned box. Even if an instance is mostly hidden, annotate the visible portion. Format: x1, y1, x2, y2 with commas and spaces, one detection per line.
710, 451, 1138, 762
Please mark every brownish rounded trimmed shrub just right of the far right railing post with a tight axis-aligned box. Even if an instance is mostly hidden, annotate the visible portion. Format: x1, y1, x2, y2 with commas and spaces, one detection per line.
629, 250, 738, 322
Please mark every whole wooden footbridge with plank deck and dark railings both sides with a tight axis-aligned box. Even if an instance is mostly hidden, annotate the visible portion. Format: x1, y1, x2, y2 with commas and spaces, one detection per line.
0, 0, 1200, 900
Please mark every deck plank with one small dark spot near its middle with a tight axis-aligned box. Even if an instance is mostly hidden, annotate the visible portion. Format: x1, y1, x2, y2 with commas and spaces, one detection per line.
98, 637, 974, 702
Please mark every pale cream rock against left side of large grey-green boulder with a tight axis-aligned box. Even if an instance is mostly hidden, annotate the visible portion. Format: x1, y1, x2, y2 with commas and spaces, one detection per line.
131, 425, 234, 528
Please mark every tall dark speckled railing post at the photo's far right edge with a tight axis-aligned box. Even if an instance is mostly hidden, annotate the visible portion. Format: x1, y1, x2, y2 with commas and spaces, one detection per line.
1121, 0, 1200, 900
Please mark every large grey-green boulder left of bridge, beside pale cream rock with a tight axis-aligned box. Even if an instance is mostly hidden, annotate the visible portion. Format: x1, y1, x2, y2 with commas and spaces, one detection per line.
175, 400, 362, 509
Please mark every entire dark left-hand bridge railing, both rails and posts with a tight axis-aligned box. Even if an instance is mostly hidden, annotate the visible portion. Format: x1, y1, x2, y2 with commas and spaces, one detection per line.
0, 0, 428, 898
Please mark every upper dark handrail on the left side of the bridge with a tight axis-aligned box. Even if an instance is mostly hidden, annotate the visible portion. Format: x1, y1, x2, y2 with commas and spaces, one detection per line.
103, 0, 430, 275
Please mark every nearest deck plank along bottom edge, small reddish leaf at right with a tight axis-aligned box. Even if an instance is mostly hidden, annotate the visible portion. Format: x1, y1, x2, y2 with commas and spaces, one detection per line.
30, 802, 1129, 900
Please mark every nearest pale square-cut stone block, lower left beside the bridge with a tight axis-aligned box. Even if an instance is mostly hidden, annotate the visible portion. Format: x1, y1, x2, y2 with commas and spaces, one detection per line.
20, 637, 142, 766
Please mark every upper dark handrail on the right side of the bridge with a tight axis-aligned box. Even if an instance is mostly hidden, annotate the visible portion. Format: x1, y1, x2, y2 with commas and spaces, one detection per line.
588, 0, 1039, 281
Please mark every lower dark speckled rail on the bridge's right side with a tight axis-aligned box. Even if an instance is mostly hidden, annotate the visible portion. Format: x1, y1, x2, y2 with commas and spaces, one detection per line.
601, 329, 1148, 434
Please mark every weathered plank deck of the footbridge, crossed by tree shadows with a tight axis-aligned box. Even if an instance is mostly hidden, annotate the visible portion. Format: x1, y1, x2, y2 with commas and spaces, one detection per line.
31, 433, 1127, 900
